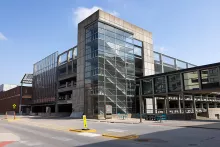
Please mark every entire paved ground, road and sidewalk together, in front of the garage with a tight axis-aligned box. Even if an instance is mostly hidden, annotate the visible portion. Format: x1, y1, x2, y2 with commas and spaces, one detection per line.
0, 117, 220, 147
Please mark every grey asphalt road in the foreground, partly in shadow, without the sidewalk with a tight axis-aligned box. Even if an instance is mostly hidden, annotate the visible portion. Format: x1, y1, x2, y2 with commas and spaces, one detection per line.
0, 120, 220, 147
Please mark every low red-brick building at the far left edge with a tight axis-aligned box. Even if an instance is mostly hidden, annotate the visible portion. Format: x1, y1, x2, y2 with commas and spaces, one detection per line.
0, 86, 32, 114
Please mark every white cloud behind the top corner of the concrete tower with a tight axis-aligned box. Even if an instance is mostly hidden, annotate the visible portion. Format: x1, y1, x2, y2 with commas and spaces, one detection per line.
73, 6, 119, 26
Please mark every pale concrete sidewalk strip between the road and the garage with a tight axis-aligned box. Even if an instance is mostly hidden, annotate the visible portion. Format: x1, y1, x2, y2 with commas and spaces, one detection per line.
3, 116, 220, 130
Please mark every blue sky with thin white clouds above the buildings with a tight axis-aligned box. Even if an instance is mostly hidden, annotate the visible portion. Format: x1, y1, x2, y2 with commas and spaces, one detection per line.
0, 0, 220, 84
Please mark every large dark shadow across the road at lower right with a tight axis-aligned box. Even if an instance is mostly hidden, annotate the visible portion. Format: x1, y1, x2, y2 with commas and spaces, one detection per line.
76, 123, 220, 147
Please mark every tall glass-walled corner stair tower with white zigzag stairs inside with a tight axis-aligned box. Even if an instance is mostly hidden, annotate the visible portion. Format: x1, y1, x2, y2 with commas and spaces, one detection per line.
85, 22, 135, 115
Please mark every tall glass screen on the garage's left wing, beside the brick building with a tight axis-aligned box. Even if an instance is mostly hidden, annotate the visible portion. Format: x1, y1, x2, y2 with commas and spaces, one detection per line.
32, 52, 58, 103
